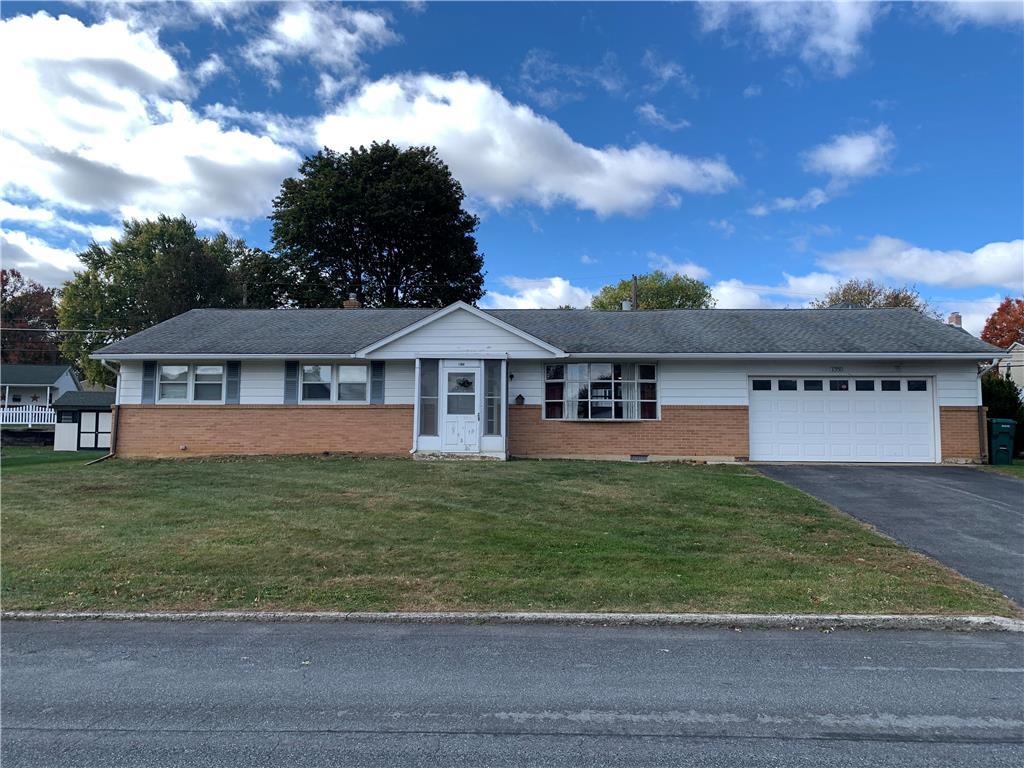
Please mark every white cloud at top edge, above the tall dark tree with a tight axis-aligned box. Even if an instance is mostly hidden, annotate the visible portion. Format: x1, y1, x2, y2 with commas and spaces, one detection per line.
242, 3, 398, 98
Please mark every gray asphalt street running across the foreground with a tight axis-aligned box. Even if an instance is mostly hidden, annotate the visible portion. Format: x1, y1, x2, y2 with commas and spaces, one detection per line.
0, 621, 1024, 768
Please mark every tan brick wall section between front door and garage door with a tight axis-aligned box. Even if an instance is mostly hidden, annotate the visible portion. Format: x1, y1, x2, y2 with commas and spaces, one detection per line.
509, 406, 750, 460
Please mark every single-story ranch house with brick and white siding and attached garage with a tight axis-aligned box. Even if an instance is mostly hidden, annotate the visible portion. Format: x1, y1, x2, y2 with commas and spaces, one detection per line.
88, 302, 1002, 462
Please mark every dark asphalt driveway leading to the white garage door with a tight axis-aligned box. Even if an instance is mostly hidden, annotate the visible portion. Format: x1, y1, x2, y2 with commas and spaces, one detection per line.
759, 465, 1024, 605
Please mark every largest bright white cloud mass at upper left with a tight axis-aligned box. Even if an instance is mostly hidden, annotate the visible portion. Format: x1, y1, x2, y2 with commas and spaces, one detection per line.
0, 12, 299, 226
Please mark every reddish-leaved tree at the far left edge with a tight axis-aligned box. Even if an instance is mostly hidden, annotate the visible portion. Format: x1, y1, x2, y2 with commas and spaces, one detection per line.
0, 269, 60, 364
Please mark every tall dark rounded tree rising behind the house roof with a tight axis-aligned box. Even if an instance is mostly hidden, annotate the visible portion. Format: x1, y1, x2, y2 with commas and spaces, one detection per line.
270, 142, 483, 307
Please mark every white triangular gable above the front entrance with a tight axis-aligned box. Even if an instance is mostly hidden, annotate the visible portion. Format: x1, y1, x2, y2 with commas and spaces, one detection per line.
369, 309, 552, 359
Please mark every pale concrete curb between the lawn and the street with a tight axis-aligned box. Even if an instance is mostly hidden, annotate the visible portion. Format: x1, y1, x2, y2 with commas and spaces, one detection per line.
0, 610, 1024, 633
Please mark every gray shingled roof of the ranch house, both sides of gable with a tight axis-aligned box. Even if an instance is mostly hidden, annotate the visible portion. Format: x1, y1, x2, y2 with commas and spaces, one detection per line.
97, 309, 1001, 357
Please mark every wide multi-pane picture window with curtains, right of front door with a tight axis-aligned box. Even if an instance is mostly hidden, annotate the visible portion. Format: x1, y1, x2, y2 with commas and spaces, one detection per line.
544, 362, 657, 421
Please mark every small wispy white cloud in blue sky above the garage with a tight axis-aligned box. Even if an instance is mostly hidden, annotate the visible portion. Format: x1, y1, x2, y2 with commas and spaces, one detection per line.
748, 125, 896, 216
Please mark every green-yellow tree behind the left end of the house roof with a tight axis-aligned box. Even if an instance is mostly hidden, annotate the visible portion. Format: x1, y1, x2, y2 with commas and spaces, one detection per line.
58, 216, 280, 381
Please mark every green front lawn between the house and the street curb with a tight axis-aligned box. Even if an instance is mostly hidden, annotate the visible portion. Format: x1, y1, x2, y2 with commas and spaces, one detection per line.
2, 450, 1016, 615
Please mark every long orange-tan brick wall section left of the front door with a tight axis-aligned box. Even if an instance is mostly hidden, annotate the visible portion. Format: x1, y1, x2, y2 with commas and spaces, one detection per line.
116, 406, 413, 458
